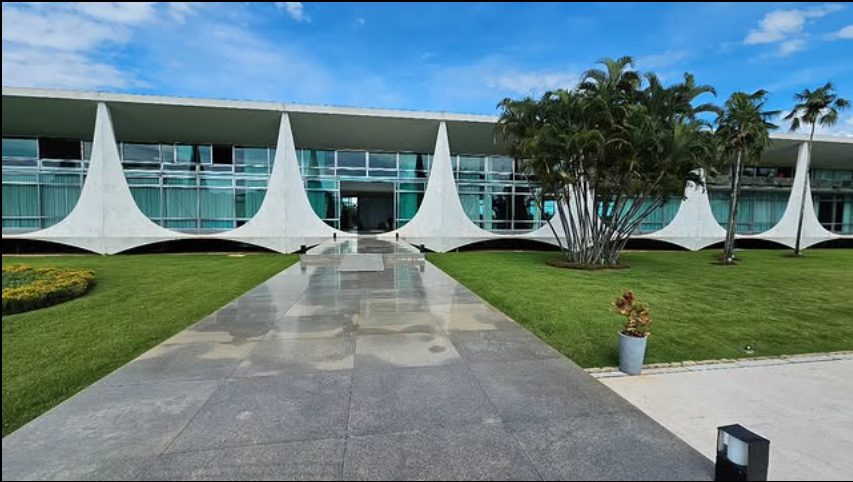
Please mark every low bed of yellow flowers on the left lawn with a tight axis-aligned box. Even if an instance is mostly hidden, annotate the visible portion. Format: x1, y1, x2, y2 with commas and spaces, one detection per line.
3, 266, 95, 316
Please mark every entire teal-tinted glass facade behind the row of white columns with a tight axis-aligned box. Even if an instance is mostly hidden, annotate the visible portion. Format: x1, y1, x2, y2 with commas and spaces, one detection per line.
2, 132, 853, 239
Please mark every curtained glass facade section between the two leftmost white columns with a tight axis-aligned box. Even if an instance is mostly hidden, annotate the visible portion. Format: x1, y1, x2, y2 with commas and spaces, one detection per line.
120, 143, 275, 233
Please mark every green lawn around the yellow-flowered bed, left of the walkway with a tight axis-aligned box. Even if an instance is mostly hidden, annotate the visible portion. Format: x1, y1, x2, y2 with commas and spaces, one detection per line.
2, 255, 298, 437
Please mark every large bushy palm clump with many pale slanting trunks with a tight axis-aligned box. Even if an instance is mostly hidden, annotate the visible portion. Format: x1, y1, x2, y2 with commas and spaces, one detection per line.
497, 57, 719, 265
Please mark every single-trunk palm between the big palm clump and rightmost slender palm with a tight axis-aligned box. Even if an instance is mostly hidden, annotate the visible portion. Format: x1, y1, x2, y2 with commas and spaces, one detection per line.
717, 90, 779, 264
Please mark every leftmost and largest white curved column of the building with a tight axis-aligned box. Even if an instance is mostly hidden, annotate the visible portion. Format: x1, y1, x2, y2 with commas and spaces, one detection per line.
16, 102, 187, 254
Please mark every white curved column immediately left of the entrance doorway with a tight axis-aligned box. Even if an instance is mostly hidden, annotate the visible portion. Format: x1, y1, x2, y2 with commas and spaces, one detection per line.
212, 112, 352, 253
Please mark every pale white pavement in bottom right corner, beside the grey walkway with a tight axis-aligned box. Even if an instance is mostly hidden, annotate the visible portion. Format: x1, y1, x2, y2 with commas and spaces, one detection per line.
601, 357, 853, 480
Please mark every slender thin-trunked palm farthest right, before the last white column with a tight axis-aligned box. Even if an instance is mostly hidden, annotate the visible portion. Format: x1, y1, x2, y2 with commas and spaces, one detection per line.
785, 82, 850, 256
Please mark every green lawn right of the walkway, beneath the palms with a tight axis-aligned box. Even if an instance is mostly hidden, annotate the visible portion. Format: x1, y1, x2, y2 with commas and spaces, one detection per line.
429, 250, 853, 367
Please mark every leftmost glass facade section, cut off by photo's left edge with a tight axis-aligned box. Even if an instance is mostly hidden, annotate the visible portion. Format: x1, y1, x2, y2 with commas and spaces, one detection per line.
3, 138, 91, 234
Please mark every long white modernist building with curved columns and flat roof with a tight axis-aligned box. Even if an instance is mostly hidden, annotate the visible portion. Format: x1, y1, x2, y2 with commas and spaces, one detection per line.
3, 87, 853, 254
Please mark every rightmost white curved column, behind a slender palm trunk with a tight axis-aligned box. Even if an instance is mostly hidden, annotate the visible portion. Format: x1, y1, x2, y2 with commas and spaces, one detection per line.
738, 142, 840, 248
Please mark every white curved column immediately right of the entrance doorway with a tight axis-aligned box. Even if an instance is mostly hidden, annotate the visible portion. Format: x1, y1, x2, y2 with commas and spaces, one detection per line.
380, 121, 492, 252
